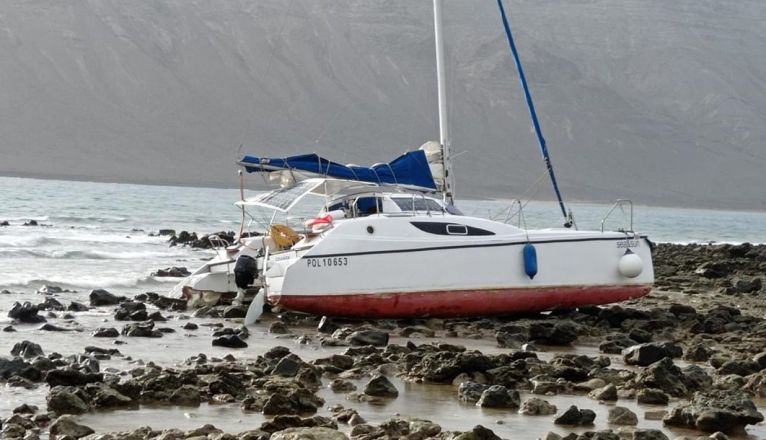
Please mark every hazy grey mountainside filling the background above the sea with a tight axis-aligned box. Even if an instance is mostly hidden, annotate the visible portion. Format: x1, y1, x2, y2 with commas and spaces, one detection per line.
0, 0, 766, 209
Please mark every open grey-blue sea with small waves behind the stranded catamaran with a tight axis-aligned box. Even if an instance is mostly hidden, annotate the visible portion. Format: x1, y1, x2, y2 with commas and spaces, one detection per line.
0, 177, 766, 292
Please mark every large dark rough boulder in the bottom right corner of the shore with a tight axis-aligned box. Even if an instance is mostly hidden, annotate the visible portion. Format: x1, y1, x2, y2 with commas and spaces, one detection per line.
662, 390, 763, 433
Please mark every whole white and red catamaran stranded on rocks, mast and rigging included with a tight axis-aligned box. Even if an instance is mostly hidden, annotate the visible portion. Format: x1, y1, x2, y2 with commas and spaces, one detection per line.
175, 0, 654, 321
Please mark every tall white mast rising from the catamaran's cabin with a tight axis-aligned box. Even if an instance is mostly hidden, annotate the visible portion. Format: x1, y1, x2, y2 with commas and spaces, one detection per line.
434, 0, 455, 205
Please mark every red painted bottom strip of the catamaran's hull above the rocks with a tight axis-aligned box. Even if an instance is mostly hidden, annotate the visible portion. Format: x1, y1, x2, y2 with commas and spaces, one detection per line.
269, 285, 651, 318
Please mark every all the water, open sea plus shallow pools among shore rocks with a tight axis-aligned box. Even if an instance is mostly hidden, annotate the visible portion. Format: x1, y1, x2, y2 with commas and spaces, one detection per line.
0, 177, 766, 439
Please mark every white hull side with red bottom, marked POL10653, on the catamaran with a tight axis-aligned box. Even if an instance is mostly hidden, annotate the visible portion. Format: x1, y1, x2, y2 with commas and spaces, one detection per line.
266, 215, 654, 318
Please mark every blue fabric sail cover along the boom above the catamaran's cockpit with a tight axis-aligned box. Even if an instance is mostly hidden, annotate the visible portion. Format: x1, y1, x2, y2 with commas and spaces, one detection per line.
239, 150, 436, 190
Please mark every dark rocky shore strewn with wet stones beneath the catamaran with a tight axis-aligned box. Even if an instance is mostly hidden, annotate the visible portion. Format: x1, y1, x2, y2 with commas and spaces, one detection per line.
0, 244, 766, 440
